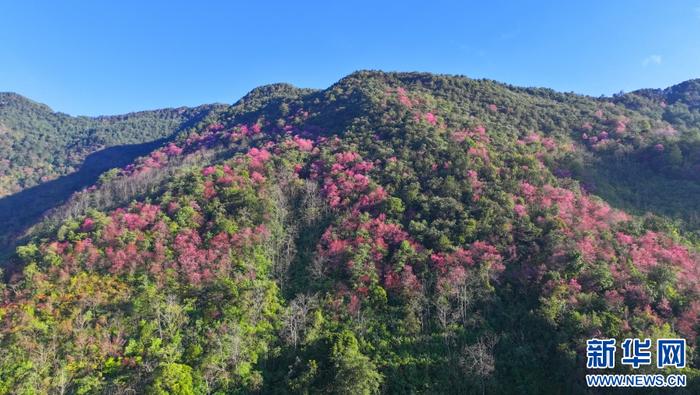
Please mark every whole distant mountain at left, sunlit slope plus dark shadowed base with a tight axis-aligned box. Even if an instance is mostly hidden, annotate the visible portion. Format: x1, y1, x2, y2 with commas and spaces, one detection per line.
0, 93, 224, 257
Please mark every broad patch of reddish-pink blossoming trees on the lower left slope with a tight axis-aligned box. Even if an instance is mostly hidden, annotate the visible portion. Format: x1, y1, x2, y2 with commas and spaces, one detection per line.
41, 198, 269, 285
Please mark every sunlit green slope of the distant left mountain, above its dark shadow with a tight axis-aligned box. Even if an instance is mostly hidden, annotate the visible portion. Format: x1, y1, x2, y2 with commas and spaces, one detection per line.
0, 92, 221, 197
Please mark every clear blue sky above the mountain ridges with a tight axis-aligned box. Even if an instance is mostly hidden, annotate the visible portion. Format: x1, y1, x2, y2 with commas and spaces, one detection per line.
0, 0, 700, 115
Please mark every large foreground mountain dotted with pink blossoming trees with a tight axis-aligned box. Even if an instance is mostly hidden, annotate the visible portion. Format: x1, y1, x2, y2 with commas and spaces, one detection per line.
0, 71, 700, 394
